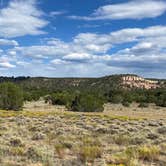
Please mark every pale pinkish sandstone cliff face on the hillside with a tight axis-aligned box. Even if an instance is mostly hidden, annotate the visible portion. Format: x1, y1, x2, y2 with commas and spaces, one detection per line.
121, 75, 159, 89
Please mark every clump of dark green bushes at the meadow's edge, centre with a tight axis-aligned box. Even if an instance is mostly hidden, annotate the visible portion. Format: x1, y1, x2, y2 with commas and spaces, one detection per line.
45, 91, 104, 112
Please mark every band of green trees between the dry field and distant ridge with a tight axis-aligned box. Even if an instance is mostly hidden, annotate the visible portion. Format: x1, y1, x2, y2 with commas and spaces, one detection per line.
0, 82, 166, 112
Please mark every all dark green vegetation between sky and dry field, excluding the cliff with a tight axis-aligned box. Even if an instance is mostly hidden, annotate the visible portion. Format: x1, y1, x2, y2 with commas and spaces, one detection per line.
0, 75, 166, 112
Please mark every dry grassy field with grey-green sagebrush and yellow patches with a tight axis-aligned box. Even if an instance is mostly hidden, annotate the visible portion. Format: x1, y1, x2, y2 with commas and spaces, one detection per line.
0, 101, 166, 166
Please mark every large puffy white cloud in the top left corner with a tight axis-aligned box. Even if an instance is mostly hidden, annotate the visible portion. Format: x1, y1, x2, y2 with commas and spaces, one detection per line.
0, 0, 48, 38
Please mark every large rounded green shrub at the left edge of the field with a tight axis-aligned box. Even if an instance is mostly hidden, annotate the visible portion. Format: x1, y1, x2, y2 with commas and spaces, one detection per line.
0, 83, 23, 111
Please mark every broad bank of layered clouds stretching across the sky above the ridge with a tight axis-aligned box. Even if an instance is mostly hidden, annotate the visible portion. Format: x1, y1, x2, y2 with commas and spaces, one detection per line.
1, 26, 166, 76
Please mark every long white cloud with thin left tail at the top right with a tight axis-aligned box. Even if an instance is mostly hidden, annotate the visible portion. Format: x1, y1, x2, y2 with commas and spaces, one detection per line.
69, 0, 166, 21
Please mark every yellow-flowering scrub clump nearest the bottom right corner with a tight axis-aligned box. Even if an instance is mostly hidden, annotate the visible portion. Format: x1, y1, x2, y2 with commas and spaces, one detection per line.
138, 145, 160, 161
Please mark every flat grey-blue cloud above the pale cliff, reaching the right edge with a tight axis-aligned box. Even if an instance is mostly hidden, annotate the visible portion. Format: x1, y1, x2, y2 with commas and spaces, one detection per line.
106, 53, 166, 73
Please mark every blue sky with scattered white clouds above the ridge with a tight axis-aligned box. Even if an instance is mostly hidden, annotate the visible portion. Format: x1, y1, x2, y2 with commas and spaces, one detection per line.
0, 0, 166, 78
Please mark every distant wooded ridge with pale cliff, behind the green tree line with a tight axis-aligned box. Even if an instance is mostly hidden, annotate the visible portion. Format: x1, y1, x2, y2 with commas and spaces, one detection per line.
0, 74, 166, 90
